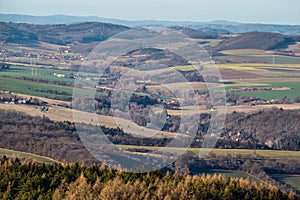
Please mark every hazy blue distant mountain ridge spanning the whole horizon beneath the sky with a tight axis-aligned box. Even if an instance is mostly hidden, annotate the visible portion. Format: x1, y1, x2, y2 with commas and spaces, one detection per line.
0, 14, 300, 35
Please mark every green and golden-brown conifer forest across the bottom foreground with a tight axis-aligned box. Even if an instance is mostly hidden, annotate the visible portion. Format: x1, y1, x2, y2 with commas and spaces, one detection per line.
0, 157, 300, 200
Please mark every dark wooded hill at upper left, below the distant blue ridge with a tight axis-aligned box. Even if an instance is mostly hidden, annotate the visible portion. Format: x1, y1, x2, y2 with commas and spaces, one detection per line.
0, 22, 129, 45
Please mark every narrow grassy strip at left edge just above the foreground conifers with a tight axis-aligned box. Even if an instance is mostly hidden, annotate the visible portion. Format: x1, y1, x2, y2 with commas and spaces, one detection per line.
0, 148, 58, 163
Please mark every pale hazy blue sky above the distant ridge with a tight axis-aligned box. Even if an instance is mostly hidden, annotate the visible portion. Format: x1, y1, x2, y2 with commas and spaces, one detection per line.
0, 0, 300, 24
